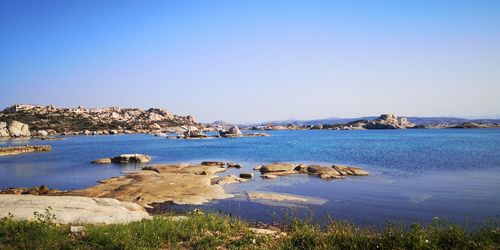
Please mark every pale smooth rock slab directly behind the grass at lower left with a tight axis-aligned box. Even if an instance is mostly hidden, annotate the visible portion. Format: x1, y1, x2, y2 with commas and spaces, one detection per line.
0, 194, 151, 224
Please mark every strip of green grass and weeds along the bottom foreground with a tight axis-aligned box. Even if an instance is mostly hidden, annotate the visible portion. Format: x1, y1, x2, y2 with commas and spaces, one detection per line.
0, 214, 500, 249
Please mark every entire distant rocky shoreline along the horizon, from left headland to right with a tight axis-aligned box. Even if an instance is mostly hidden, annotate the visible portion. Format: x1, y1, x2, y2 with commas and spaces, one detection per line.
0, 104, 500, 139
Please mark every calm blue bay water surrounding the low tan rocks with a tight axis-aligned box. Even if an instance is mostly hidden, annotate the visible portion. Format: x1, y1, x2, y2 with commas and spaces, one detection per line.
0, 129, 500, 225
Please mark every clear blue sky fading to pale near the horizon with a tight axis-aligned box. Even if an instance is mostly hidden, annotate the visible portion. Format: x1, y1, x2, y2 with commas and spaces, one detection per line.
0, 0, 500, 122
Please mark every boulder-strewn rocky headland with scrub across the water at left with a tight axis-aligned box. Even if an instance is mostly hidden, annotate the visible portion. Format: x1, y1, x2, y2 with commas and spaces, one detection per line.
0, 105, 199, 137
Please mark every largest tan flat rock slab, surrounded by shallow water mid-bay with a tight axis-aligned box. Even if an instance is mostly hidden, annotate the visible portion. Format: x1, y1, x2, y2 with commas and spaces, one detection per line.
65, 164, 232, 207
